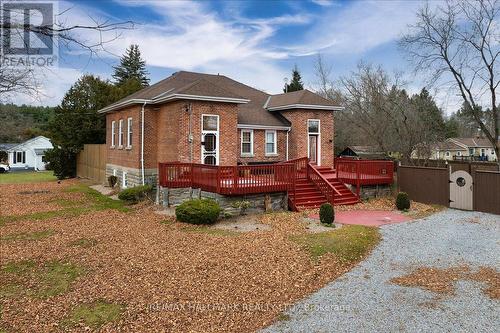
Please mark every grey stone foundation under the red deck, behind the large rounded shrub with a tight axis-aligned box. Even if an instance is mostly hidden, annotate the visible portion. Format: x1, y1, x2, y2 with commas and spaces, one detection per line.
160, 187, 288, 216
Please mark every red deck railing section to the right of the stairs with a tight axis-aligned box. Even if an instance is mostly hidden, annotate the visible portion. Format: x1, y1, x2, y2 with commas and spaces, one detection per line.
335, 158, 394, 196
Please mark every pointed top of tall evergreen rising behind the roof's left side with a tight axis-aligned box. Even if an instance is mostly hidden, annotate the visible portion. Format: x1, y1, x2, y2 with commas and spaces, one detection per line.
113, 44, 149, 87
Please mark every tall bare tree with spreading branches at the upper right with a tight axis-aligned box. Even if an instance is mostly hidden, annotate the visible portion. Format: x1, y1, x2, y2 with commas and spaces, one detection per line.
401, 0, 500, 166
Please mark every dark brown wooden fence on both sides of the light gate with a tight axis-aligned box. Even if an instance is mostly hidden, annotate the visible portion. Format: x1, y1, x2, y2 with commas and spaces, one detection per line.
398, 166, 500, 214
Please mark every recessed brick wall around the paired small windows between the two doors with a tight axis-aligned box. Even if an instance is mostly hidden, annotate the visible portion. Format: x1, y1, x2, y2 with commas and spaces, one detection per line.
238, 129, 286, 163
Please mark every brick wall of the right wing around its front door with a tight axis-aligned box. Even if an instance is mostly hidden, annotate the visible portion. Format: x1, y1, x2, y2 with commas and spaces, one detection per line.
280, 110, 334, 166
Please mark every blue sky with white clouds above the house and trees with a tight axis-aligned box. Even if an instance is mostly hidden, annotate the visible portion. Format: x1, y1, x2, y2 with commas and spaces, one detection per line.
15, 0, 464, 111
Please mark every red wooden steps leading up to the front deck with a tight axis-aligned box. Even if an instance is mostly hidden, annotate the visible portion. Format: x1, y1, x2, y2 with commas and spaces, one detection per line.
289, 166, 359, 210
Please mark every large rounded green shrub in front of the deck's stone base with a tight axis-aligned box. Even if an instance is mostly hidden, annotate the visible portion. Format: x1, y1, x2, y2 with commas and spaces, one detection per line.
175, 199, 221, 224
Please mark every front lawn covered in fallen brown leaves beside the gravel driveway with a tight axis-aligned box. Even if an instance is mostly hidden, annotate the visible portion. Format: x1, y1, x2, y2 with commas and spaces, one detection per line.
0, 180, 379, 332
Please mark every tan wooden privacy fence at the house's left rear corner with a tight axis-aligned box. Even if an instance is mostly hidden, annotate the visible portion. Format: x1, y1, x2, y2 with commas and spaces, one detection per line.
76, 144, 107, 183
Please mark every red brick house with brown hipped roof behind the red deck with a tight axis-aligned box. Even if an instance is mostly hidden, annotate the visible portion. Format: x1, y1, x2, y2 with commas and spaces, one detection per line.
99, 71, 342, 187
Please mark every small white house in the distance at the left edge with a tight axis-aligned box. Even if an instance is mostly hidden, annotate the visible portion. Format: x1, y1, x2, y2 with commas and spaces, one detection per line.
7, 136, 53, 171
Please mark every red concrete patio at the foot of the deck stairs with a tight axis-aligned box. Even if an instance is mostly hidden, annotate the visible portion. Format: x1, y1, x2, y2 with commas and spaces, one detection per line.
310, 210, 412, 227
